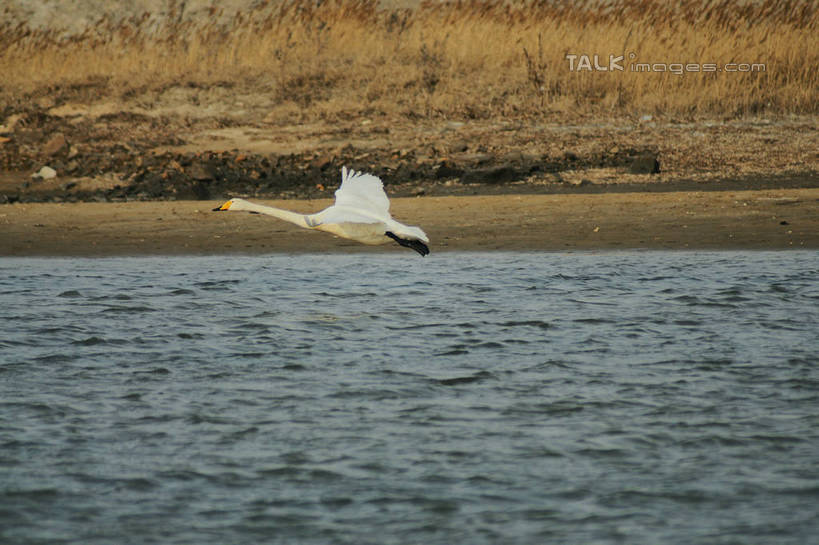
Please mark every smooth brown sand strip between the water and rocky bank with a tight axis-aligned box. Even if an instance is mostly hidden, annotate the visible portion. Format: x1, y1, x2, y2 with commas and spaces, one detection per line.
0, 189, 819, 256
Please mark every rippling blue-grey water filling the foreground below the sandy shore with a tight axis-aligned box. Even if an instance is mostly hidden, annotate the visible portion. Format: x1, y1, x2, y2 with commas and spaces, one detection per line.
0, 252, 819, 545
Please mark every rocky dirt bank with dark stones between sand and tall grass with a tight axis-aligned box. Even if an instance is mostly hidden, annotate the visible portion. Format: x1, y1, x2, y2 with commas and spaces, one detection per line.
0, 84, 819, 203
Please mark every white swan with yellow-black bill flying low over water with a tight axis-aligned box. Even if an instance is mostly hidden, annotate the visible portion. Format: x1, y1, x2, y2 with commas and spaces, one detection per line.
213, 167, 429, 256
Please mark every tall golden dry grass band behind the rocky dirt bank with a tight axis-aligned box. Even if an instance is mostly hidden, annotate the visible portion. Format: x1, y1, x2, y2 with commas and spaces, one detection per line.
0, 0, 819, 120
